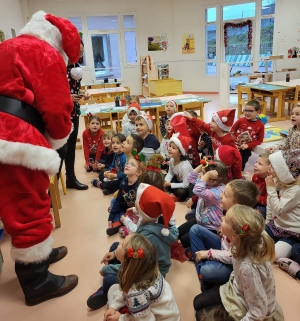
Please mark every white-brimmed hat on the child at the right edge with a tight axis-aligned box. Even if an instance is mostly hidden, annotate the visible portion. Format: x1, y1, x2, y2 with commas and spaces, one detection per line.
269, 149, 300, 184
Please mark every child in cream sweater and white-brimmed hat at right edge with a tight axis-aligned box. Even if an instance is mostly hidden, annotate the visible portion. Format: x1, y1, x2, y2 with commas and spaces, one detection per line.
266, 149, 300, 260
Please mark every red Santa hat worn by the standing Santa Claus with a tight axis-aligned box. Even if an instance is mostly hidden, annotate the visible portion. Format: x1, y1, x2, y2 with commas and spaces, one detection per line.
20, 11, 81, 63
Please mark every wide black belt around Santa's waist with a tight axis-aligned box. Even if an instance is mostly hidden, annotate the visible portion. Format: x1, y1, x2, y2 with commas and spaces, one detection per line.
0, 95, 45, 135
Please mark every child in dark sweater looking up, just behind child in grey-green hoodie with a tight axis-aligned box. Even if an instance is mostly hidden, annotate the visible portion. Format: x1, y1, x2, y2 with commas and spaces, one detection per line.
106, 150, 144, 236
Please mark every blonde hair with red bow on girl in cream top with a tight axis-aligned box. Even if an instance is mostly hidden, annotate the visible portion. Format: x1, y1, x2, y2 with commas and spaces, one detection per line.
229, 205, 275, 264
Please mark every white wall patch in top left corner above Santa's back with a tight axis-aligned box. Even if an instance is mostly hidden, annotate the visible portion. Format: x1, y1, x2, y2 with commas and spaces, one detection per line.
0, 0, 24, 39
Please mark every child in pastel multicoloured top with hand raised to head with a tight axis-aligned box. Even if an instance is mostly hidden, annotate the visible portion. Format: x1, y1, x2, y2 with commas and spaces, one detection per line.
178, 159, 228, 248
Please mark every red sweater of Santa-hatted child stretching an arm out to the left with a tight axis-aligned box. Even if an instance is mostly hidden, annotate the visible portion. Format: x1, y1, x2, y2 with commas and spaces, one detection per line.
188, 118, 236, 150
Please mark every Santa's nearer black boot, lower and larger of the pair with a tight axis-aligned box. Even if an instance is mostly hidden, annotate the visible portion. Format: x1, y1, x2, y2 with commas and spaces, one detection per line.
15, 259, 78, 305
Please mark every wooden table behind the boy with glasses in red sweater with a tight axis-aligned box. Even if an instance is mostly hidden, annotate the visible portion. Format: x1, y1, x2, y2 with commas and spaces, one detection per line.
238, 82, 293, 122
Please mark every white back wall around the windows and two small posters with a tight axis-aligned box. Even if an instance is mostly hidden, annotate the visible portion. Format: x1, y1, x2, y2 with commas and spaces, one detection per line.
21, 0, 300, 94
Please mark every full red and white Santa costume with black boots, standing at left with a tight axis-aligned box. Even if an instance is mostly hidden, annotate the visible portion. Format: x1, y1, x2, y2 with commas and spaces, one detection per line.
0, 11, 80, 305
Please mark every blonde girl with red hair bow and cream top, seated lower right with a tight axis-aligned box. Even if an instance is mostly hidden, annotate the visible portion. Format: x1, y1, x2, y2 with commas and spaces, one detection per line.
194, 205, 284, 321
